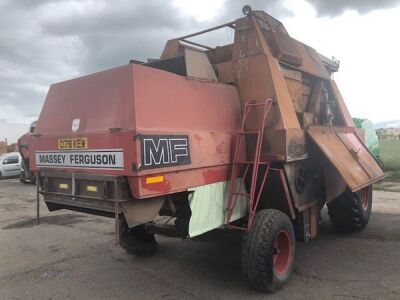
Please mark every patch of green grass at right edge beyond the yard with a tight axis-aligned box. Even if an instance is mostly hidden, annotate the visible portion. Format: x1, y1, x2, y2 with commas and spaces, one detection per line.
380, 141, 400, 171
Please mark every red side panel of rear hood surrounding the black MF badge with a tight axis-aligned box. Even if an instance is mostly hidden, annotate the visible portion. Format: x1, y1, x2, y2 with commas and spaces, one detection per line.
129, 65, 241, 198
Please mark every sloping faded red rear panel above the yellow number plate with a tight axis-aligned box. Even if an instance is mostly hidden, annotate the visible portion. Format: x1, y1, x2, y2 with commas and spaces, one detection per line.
35, 65, 135, 137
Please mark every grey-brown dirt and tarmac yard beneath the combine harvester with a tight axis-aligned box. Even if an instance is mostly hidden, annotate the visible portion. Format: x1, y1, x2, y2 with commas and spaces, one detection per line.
0, 180, 400, 299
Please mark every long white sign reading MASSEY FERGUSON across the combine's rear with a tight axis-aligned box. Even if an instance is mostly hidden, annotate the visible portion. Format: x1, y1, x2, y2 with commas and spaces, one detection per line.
35, 149, 124, 170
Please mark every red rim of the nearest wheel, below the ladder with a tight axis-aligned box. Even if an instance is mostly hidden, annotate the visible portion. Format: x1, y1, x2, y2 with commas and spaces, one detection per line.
273, 230, 292, 275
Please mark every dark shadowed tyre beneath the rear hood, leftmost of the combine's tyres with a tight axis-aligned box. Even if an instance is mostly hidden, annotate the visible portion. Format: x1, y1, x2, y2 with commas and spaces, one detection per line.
119, 219, 158, 256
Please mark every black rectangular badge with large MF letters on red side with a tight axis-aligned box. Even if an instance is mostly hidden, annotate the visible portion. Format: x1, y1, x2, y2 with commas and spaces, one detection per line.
140, 135, 190, 169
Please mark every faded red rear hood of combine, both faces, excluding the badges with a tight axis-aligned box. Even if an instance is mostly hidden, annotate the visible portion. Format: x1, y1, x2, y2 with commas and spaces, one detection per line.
29, 64, 241, 198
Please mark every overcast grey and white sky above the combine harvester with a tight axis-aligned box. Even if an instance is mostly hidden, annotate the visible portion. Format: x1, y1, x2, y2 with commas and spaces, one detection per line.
0, 0, 400, 140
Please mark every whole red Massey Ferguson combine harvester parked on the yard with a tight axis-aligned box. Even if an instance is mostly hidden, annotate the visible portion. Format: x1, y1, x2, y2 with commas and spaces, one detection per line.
20, 6, 384, 291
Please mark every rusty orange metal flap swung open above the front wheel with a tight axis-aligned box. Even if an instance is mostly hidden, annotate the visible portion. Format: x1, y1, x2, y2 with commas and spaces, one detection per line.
307, 126, 385, 192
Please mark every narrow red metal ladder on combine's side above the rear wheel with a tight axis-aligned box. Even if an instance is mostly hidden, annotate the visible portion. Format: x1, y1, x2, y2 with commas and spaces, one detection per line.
226, 99, 273, 229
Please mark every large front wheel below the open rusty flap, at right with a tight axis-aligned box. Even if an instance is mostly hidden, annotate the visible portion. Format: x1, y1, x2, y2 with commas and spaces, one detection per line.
328, 185, 372, 232
